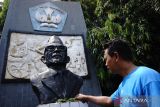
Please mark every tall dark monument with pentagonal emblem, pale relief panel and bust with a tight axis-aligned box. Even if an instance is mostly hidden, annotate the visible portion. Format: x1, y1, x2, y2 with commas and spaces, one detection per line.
0, 0, 101, 107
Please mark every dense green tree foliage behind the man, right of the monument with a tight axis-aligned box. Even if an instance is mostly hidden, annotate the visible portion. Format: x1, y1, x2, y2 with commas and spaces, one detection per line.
80, 0, 160, 94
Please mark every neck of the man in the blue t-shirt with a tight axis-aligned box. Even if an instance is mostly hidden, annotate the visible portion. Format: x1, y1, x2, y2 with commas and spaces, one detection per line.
120, 62, 137, 77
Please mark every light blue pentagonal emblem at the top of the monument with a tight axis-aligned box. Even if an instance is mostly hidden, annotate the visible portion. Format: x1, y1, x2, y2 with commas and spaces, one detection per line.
29, 2, 67, 32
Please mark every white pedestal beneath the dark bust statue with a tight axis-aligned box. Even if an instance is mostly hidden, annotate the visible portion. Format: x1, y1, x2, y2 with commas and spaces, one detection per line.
37, 102, 88, 107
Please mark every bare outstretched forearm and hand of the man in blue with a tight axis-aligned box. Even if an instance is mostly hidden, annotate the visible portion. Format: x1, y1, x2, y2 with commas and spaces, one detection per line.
76, 94, 113, 107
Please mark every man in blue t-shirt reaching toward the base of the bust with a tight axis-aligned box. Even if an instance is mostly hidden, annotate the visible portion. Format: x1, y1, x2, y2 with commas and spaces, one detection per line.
76, 39, 160, 107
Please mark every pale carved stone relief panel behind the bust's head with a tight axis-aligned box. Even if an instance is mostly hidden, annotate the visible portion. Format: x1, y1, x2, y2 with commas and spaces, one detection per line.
5, 33, 88, 79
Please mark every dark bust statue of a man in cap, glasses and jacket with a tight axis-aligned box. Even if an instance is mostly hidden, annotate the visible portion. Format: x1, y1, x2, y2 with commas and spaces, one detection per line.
30, 36, 83, 104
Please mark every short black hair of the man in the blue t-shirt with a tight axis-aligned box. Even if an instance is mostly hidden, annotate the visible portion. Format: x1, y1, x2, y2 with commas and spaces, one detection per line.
103, 39, 133, 61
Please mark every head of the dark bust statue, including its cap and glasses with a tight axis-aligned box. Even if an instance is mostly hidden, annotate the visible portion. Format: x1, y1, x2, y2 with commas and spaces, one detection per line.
41, 36, 70, 66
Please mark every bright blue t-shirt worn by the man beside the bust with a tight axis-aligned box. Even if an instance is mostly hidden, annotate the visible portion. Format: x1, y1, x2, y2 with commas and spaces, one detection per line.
111, 66, 160, 107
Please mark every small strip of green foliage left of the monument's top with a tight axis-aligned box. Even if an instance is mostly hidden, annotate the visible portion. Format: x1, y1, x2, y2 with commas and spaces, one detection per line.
0, 0, 9, 31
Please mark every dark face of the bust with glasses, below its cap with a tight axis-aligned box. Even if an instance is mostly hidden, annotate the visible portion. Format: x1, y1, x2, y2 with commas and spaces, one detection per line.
44, 45, 68, 64
